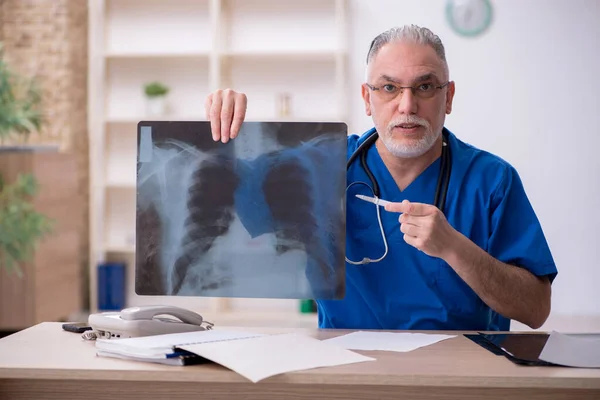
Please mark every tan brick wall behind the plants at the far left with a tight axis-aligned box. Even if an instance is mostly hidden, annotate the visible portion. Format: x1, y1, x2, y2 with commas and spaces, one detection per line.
0, 0, 89, 306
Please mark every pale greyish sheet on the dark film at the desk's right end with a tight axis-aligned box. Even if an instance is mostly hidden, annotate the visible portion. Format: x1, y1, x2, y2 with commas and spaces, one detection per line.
538, 332, 600, 368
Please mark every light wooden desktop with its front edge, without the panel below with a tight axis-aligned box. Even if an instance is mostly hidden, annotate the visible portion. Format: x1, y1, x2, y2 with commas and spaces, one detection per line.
0, 323, 600, 398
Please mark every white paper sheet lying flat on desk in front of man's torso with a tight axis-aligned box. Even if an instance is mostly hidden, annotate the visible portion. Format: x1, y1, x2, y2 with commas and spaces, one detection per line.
324, 331, 456, 352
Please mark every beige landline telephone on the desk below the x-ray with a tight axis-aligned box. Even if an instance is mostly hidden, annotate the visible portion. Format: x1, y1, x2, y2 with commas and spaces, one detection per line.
88, 306, 214, 339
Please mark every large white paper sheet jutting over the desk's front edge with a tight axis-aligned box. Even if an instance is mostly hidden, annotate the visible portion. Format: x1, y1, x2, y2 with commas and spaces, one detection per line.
181, 333, 375, 383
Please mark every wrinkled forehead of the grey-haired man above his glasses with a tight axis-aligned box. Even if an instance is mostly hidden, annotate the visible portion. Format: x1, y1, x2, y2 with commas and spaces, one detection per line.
367, 41, 448, 83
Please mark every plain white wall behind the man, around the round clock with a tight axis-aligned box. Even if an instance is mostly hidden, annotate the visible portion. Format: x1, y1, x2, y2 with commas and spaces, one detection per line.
349, 0, 600, 318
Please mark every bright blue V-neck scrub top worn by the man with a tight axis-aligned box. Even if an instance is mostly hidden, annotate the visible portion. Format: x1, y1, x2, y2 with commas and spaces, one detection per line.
317, 129, 557, 330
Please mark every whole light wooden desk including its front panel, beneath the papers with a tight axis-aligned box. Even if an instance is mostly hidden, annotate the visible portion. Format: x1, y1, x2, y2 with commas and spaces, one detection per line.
0, 323, 600, 400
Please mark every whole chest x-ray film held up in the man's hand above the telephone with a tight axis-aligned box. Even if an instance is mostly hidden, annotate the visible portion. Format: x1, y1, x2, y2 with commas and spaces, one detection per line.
135, 121, 347, 299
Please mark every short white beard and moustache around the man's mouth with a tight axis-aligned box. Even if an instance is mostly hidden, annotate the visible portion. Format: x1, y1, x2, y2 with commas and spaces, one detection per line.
379, 116, 442, 158
